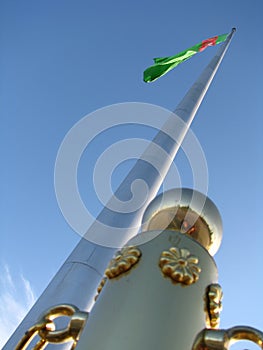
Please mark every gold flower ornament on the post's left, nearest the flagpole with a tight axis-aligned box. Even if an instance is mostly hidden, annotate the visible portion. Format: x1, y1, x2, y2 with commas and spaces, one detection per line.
105, 246, 142, 278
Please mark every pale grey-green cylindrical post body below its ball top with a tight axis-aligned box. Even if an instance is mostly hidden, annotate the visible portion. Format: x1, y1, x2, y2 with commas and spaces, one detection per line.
77, 230, 217, 350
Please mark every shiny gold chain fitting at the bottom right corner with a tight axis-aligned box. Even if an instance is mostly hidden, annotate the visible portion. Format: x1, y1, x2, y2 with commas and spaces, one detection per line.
192, 326, 263, 350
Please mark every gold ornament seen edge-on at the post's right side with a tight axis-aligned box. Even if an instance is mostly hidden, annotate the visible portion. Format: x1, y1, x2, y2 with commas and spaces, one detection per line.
205, 283, 223, 328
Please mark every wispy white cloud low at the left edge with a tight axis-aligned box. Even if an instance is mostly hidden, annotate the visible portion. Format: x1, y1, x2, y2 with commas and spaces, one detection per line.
0, 264, 36, 348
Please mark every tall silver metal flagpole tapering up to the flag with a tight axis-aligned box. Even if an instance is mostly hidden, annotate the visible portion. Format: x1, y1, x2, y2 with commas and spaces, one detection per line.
3, 28, 235, 350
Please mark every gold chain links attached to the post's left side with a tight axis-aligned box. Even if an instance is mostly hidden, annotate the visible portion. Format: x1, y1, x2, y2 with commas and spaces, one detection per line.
15, 304, 88, 350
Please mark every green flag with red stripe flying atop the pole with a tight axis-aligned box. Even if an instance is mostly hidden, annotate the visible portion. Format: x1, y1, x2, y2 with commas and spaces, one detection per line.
143, 34, 228, 83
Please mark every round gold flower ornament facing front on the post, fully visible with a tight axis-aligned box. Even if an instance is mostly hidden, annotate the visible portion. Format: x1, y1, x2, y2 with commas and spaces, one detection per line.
159, 247, 201, 285
